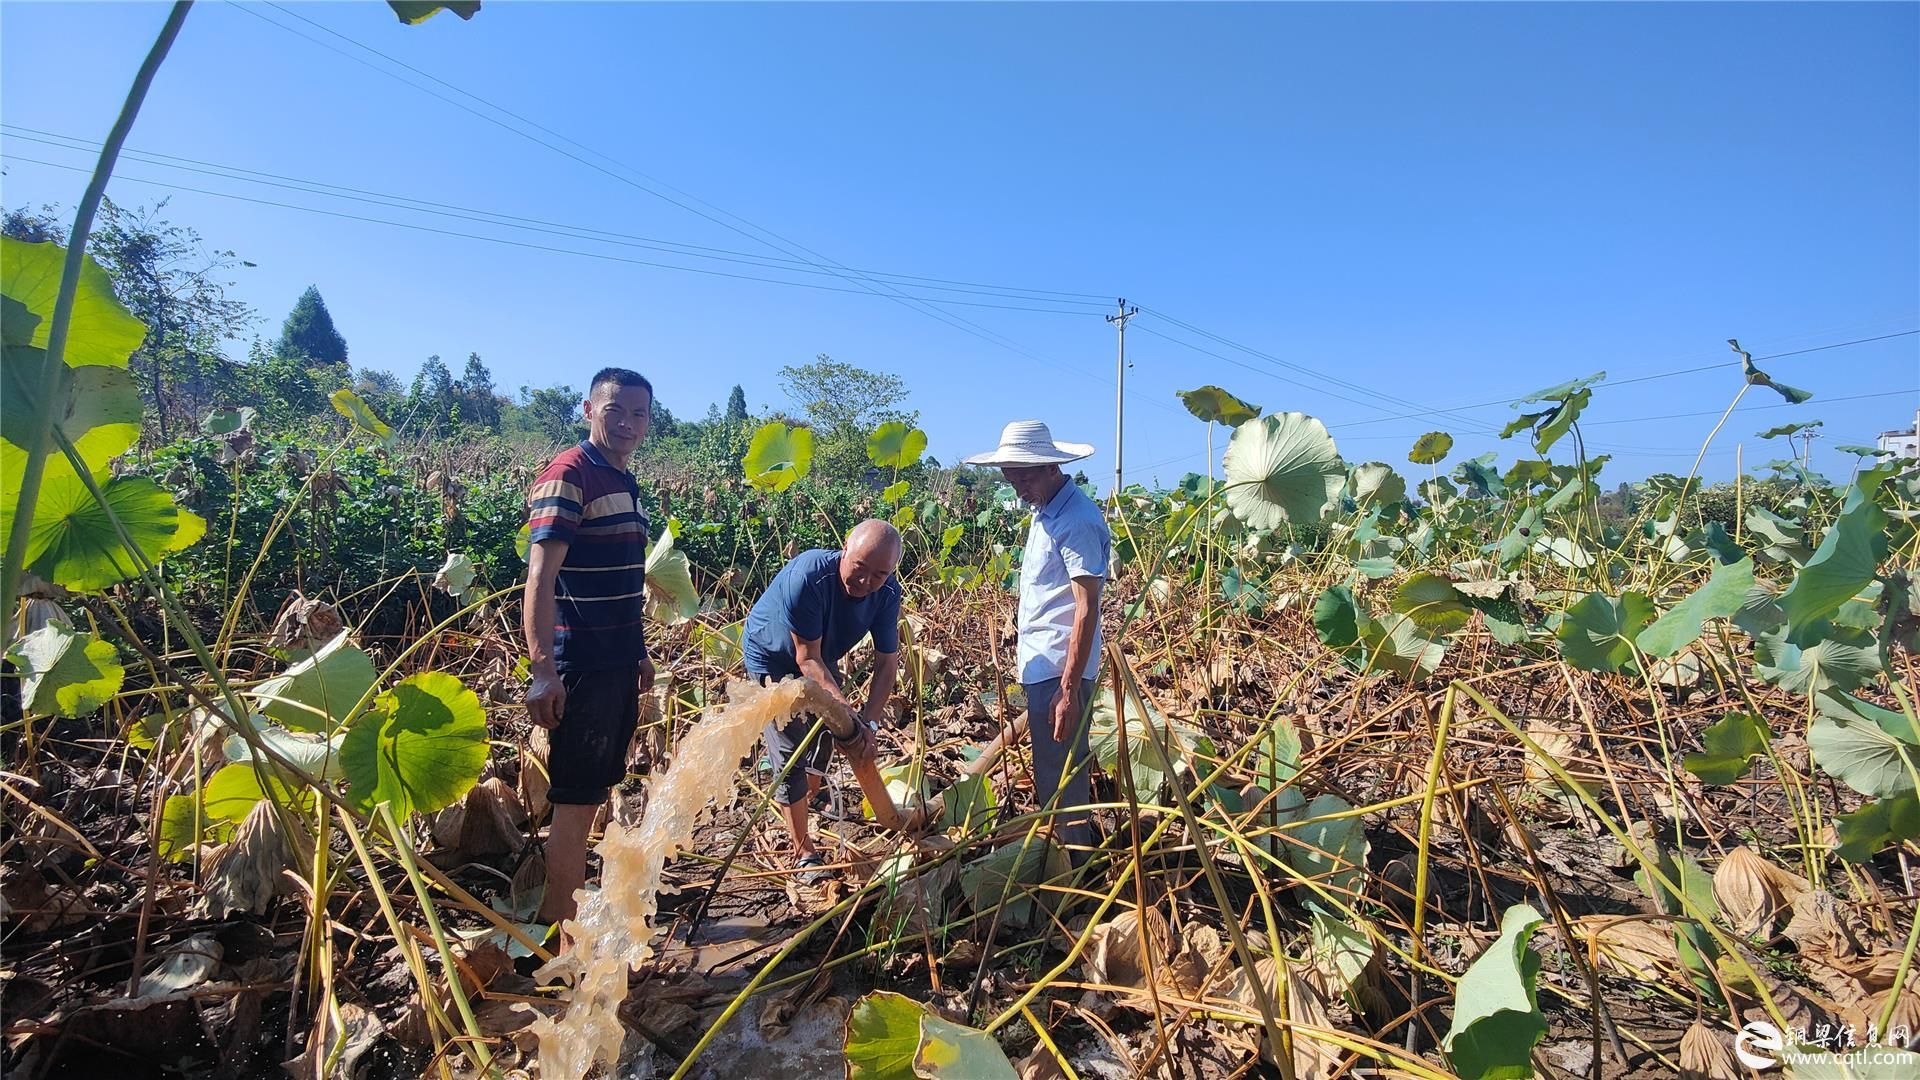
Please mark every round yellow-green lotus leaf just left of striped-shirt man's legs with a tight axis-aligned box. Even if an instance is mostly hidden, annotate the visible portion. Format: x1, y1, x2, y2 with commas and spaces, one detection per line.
340, 671, 488, 817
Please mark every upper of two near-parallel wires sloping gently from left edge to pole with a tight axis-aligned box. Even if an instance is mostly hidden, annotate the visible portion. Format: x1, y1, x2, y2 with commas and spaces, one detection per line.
0, 123, 1106, 307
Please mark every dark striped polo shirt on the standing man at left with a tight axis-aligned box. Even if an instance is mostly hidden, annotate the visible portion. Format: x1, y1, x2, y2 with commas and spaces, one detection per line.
526, 442, 649, 671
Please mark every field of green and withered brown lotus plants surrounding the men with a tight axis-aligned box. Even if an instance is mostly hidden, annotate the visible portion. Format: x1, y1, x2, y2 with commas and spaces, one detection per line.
0, 4, 1920, 1080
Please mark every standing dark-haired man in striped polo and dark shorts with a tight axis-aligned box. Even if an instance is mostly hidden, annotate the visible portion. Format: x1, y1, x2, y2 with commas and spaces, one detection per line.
520, 367, 653, 924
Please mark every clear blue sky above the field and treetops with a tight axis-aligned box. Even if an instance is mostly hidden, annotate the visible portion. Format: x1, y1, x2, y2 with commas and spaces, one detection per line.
0, 2, 1920, 488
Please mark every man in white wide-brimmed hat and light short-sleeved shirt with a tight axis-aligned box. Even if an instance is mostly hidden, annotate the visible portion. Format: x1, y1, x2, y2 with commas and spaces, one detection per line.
966, 421, 1112, 846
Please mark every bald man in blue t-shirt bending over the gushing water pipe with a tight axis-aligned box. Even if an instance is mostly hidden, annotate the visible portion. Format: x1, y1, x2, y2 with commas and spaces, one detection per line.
741, 519, 900, 867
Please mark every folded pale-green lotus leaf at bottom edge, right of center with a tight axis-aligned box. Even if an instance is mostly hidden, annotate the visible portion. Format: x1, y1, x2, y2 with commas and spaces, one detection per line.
1440, 903, 1548, 1080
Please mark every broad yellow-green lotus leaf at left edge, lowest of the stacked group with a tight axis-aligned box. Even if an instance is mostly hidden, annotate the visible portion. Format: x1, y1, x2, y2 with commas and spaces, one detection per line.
0, 469, 207, 592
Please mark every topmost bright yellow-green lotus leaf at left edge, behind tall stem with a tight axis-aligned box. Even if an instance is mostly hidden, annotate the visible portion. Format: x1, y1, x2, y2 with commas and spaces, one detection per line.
0, 236, 146, 367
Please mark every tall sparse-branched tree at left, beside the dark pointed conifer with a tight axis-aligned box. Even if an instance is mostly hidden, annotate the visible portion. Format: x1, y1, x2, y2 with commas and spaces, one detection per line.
86, 200, 255, 442
